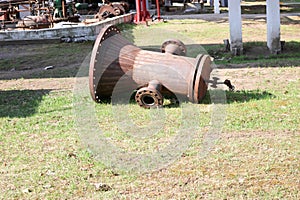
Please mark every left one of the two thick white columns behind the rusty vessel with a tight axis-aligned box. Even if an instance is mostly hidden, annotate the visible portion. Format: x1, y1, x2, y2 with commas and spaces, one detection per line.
228, 0, 243, 55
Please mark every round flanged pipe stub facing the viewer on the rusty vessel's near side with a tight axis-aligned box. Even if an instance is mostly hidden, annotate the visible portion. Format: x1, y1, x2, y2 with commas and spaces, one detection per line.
135, 80, 163, 108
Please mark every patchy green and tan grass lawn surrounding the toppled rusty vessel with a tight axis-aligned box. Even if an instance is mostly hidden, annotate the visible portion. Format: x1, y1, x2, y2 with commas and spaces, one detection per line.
0, 16, 300, 199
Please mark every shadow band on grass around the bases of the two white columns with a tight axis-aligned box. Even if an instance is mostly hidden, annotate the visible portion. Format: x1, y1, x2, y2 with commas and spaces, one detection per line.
207, 41, 300, 69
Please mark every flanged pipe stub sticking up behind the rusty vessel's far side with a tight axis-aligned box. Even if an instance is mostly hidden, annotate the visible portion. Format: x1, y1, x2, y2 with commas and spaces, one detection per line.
161, 39, 186, 56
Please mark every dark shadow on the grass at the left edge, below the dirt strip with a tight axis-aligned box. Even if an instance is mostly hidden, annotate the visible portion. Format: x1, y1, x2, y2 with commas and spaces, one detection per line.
0, 90, 51, 118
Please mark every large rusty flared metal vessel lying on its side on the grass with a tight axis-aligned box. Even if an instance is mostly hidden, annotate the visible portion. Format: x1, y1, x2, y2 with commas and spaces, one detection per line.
89, 25, 212, 108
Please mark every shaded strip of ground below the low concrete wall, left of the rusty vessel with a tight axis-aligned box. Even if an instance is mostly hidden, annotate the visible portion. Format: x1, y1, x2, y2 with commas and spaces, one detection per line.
0, 42, 93, 72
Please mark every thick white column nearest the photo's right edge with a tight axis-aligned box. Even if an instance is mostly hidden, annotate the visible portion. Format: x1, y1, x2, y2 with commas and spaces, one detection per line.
267, 0, 281, 54
